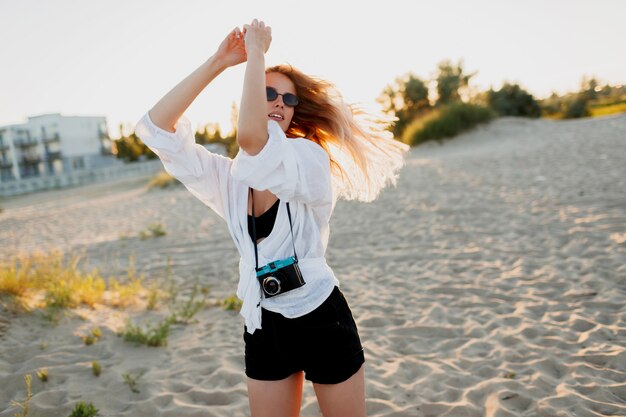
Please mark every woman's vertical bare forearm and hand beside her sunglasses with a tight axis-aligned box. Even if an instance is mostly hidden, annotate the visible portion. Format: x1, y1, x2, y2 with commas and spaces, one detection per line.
237, 19, 272, 155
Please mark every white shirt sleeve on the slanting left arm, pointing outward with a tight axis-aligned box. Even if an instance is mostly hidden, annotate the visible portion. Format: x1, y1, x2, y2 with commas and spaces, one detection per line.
135, 113, 233, 219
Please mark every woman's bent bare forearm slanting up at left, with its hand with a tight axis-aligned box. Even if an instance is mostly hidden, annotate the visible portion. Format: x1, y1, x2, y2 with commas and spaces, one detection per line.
148, 27, 247, 133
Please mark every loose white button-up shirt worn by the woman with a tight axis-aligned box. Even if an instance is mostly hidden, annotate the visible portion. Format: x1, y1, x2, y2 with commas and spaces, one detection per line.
135, 113, 339, 333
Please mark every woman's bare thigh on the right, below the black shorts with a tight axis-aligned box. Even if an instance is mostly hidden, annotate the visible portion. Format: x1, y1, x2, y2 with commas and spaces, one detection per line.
313, 365, 366, 417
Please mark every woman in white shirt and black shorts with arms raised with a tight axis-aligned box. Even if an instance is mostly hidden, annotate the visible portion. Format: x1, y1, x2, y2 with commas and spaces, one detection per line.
135, 19, 408, 417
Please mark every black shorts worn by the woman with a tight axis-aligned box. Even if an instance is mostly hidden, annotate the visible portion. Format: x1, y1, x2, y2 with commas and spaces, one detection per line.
243, 286, 365, 384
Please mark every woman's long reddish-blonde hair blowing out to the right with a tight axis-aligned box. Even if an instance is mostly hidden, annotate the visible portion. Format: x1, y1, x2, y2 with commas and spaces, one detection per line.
265, 65, 409, 202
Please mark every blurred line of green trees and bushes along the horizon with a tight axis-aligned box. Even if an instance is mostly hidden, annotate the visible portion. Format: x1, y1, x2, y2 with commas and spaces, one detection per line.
113, 60, 626, 162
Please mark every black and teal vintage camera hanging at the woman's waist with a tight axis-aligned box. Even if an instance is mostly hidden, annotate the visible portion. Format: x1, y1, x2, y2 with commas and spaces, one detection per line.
256, 256, 305, 298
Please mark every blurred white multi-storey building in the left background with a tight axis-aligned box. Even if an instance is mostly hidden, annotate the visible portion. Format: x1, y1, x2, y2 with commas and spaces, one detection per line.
0, 113, 114, 182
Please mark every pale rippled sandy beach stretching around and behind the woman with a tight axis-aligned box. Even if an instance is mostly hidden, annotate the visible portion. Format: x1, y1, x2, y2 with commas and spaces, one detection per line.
0, 114, 626, 417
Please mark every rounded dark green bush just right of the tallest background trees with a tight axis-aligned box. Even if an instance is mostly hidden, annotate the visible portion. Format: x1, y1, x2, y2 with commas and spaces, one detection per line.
487, 83, 541, 117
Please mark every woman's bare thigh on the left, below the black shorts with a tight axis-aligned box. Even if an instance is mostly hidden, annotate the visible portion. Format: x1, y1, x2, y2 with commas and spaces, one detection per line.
248, 371, 304, 417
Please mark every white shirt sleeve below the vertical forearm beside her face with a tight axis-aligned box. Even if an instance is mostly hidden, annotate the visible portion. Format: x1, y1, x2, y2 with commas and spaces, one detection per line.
231, 120, 333, 205
